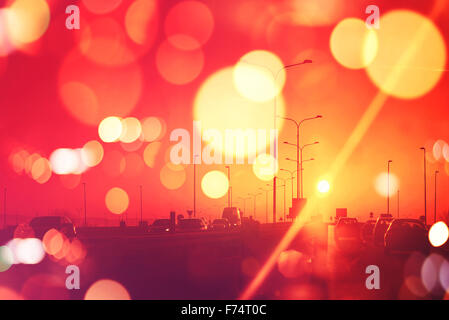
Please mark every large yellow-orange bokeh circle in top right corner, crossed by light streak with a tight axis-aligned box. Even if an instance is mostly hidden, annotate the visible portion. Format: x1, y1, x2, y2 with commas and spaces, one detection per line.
367, 10, 446, 99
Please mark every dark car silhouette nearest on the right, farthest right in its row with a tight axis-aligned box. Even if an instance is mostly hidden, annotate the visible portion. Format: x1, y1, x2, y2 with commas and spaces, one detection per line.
384, 219, 430, 254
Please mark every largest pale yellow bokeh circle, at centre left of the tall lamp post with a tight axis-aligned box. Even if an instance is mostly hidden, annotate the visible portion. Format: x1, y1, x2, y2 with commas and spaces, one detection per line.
194, 67, 284, 155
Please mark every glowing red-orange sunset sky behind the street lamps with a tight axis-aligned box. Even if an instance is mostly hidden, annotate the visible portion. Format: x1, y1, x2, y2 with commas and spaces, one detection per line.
0, 0, 449, 224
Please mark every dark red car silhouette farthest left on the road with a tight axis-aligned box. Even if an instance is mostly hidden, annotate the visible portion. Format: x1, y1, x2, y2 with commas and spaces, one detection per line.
29, 216, 77, 239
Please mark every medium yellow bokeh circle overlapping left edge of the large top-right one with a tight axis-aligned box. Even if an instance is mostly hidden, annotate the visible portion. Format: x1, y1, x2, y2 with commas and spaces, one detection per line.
330, 18, 378, 69
